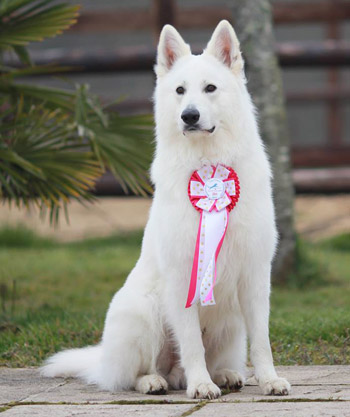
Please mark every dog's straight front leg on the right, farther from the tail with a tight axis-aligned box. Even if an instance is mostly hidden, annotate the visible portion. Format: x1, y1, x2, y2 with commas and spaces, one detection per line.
239, 266, 290, 395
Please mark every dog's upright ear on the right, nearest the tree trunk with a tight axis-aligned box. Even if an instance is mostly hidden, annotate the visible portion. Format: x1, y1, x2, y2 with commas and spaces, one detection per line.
204, 20, 244, 74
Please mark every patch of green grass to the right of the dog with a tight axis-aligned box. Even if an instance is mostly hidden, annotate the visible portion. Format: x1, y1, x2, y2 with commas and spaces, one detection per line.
270, 234, 350, 365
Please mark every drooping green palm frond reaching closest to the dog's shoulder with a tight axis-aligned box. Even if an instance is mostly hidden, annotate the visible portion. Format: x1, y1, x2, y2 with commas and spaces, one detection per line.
0, 83, 153, 195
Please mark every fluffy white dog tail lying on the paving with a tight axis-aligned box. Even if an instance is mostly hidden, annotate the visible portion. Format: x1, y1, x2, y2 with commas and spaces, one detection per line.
40, 345, 101, 383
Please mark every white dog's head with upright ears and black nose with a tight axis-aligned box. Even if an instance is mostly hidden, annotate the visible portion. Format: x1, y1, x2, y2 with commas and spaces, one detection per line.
155, 21, 245, 138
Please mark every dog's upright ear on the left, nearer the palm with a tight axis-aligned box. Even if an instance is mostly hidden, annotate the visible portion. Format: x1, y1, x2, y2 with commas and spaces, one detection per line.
154, 25, 191, 77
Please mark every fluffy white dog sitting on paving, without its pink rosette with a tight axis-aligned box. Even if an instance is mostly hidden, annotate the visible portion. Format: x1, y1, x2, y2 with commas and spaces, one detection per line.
42, 21, 290, 399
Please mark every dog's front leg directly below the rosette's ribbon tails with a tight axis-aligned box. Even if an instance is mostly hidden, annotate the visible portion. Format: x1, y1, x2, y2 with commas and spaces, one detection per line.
168, 292, 221, 399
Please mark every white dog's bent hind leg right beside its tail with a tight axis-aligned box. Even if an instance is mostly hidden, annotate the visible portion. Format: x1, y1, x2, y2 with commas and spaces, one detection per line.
97, 256, 167, 393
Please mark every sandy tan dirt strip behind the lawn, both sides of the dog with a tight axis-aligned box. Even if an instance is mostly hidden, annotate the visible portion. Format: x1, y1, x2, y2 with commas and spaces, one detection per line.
0, 194, 350, 241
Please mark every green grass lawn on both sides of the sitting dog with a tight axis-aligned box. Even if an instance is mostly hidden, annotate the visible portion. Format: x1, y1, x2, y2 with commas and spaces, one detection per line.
0, 227, 350, 367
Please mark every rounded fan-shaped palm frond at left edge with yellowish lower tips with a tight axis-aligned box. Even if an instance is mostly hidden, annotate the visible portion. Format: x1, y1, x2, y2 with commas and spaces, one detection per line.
0, 106, 102, 223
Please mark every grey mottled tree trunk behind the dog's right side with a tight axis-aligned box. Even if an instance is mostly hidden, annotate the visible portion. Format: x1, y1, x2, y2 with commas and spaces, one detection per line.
231, 0, 295, 282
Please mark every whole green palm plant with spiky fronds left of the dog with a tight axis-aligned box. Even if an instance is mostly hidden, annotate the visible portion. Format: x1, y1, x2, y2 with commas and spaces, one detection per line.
0, 0, 152, 222
